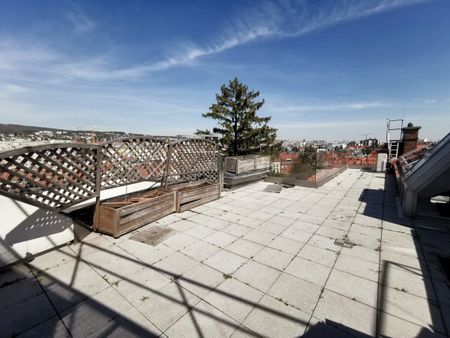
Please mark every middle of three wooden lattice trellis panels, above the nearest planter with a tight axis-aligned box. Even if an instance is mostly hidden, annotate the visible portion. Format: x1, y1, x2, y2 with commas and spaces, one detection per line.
100, 137, 169, 189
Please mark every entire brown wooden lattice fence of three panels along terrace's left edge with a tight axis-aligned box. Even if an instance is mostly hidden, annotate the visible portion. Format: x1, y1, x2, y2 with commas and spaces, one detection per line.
0, 137, 220, 210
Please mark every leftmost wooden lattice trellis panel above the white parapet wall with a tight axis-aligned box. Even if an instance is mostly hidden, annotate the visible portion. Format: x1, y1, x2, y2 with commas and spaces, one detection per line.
0, 144, 97, 210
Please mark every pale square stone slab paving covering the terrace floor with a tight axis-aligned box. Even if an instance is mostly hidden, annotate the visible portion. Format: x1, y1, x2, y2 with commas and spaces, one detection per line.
0, 170, 450, 337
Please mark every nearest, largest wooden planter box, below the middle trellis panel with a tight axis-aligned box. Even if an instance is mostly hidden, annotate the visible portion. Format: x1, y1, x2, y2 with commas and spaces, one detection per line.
94, 189, 176, 238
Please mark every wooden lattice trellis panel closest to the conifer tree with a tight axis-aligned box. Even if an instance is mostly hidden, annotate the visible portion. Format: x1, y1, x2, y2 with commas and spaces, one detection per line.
167, 139, 219, 181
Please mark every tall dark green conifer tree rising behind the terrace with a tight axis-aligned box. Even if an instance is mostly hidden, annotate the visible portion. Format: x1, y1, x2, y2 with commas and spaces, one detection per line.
203, 77, 279, 156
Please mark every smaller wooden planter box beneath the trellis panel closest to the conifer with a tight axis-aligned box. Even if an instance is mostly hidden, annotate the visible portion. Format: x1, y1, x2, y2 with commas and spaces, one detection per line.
169, 181, 220, 212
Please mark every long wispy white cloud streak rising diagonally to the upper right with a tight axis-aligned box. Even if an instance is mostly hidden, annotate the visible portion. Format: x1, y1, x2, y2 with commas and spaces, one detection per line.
110, 0, 429, 77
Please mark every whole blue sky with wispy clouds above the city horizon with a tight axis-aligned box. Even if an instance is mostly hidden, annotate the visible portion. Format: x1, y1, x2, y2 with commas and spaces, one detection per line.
0, 0, 450, 140
